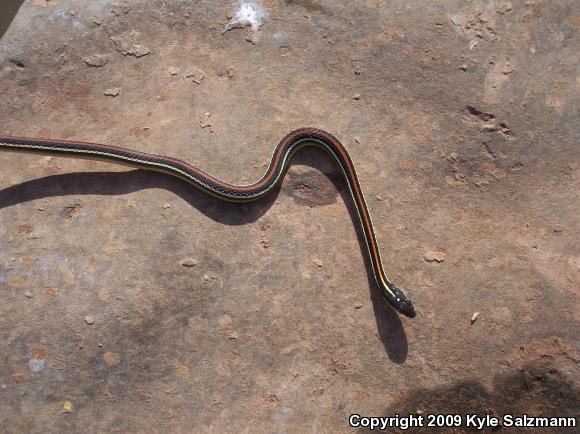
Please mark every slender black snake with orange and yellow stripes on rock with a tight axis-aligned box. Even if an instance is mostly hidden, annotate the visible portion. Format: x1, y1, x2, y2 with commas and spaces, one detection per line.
0, 128, 416, 318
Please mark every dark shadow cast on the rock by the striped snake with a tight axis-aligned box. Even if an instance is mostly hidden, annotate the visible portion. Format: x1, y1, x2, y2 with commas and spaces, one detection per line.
0, 148, 408, 364
